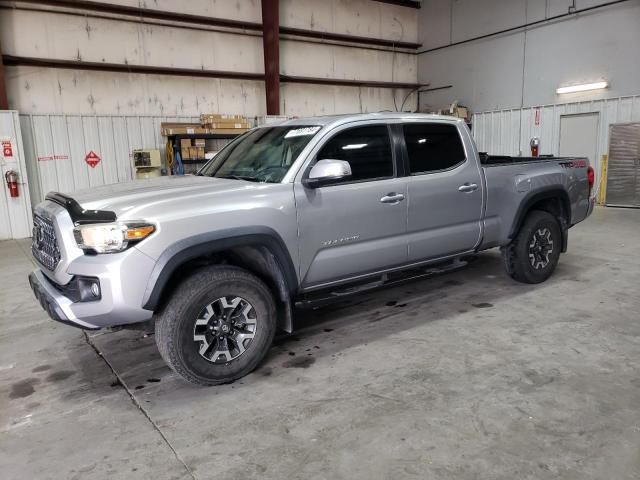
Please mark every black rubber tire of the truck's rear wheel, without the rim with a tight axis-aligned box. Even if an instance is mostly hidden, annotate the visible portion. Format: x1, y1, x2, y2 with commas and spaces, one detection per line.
502, 210, 562, 283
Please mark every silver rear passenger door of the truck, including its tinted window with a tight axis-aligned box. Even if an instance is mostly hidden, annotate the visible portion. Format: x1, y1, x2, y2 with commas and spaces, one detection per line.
402, 121, 482, 261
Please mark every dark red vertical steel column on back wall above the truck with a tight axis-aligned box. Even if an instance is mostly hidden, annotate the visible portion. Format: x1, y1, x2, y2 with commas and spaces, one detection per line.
262, 0, 280, 115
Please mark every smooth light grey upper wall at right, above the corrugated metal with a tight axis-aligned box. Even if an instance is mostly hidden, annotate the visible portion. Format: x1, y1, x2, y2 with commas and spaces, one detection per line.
418, 0, 640, 112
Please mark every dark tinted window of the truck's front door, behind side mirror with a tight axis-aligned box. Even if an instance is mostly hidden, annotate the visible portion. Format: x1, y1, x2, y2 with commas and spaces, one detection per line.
318, 125, 393, 182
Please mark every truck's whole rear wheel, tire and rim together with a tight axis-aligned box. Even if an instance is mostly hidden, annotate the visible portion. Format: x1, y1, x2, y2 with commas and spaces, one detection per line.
502, 210, 562, 283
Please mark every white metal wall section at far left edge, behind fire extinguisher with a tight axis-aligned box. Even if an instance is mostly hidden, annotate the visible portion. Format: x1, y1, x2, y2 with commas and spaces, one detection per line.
0, 110, 32, 240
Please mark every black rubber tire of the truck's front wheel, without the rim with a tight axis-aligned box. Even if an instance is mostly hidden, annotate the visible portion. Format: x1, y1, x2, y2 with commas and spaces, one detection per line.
155, 265, 276, 385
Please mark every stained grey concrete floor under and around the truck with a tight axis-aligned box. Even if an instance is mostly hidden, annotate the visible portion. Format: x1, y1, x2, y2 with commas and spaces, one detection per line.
0, 209, 640, 480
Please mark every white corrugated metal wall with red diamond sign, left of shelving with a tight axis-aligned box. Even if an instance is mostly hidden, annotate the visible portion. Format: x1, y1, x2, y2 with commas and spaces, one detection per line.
20, 114, 200, 205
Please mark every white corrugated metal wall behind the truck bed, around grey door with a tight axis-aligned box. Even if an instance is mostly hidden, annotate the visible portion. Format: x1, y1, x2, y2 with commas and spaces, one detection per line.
473, 96, 640, 182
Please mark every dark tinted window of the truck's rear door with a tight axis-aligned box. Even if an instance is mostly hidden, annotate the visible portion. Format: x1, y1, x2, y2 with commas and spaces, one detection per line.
402, 123, 465, 174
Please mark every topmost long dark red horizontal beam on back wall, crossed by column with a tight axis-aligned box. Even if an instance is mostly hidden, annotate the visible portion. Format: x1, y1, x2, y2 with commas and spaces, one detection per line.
20, 0, 421, 50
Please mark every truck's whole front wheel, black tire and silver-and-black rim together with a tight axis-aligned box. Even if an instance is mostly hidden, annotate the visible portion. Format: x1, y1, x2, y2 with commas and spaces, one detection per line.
155, 265, 276, 385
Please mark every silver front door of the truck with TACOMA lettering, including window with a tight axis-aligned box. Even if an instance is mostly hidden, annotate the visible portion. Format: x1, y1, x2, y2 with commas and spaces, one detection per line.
294, 123, 408, 290
